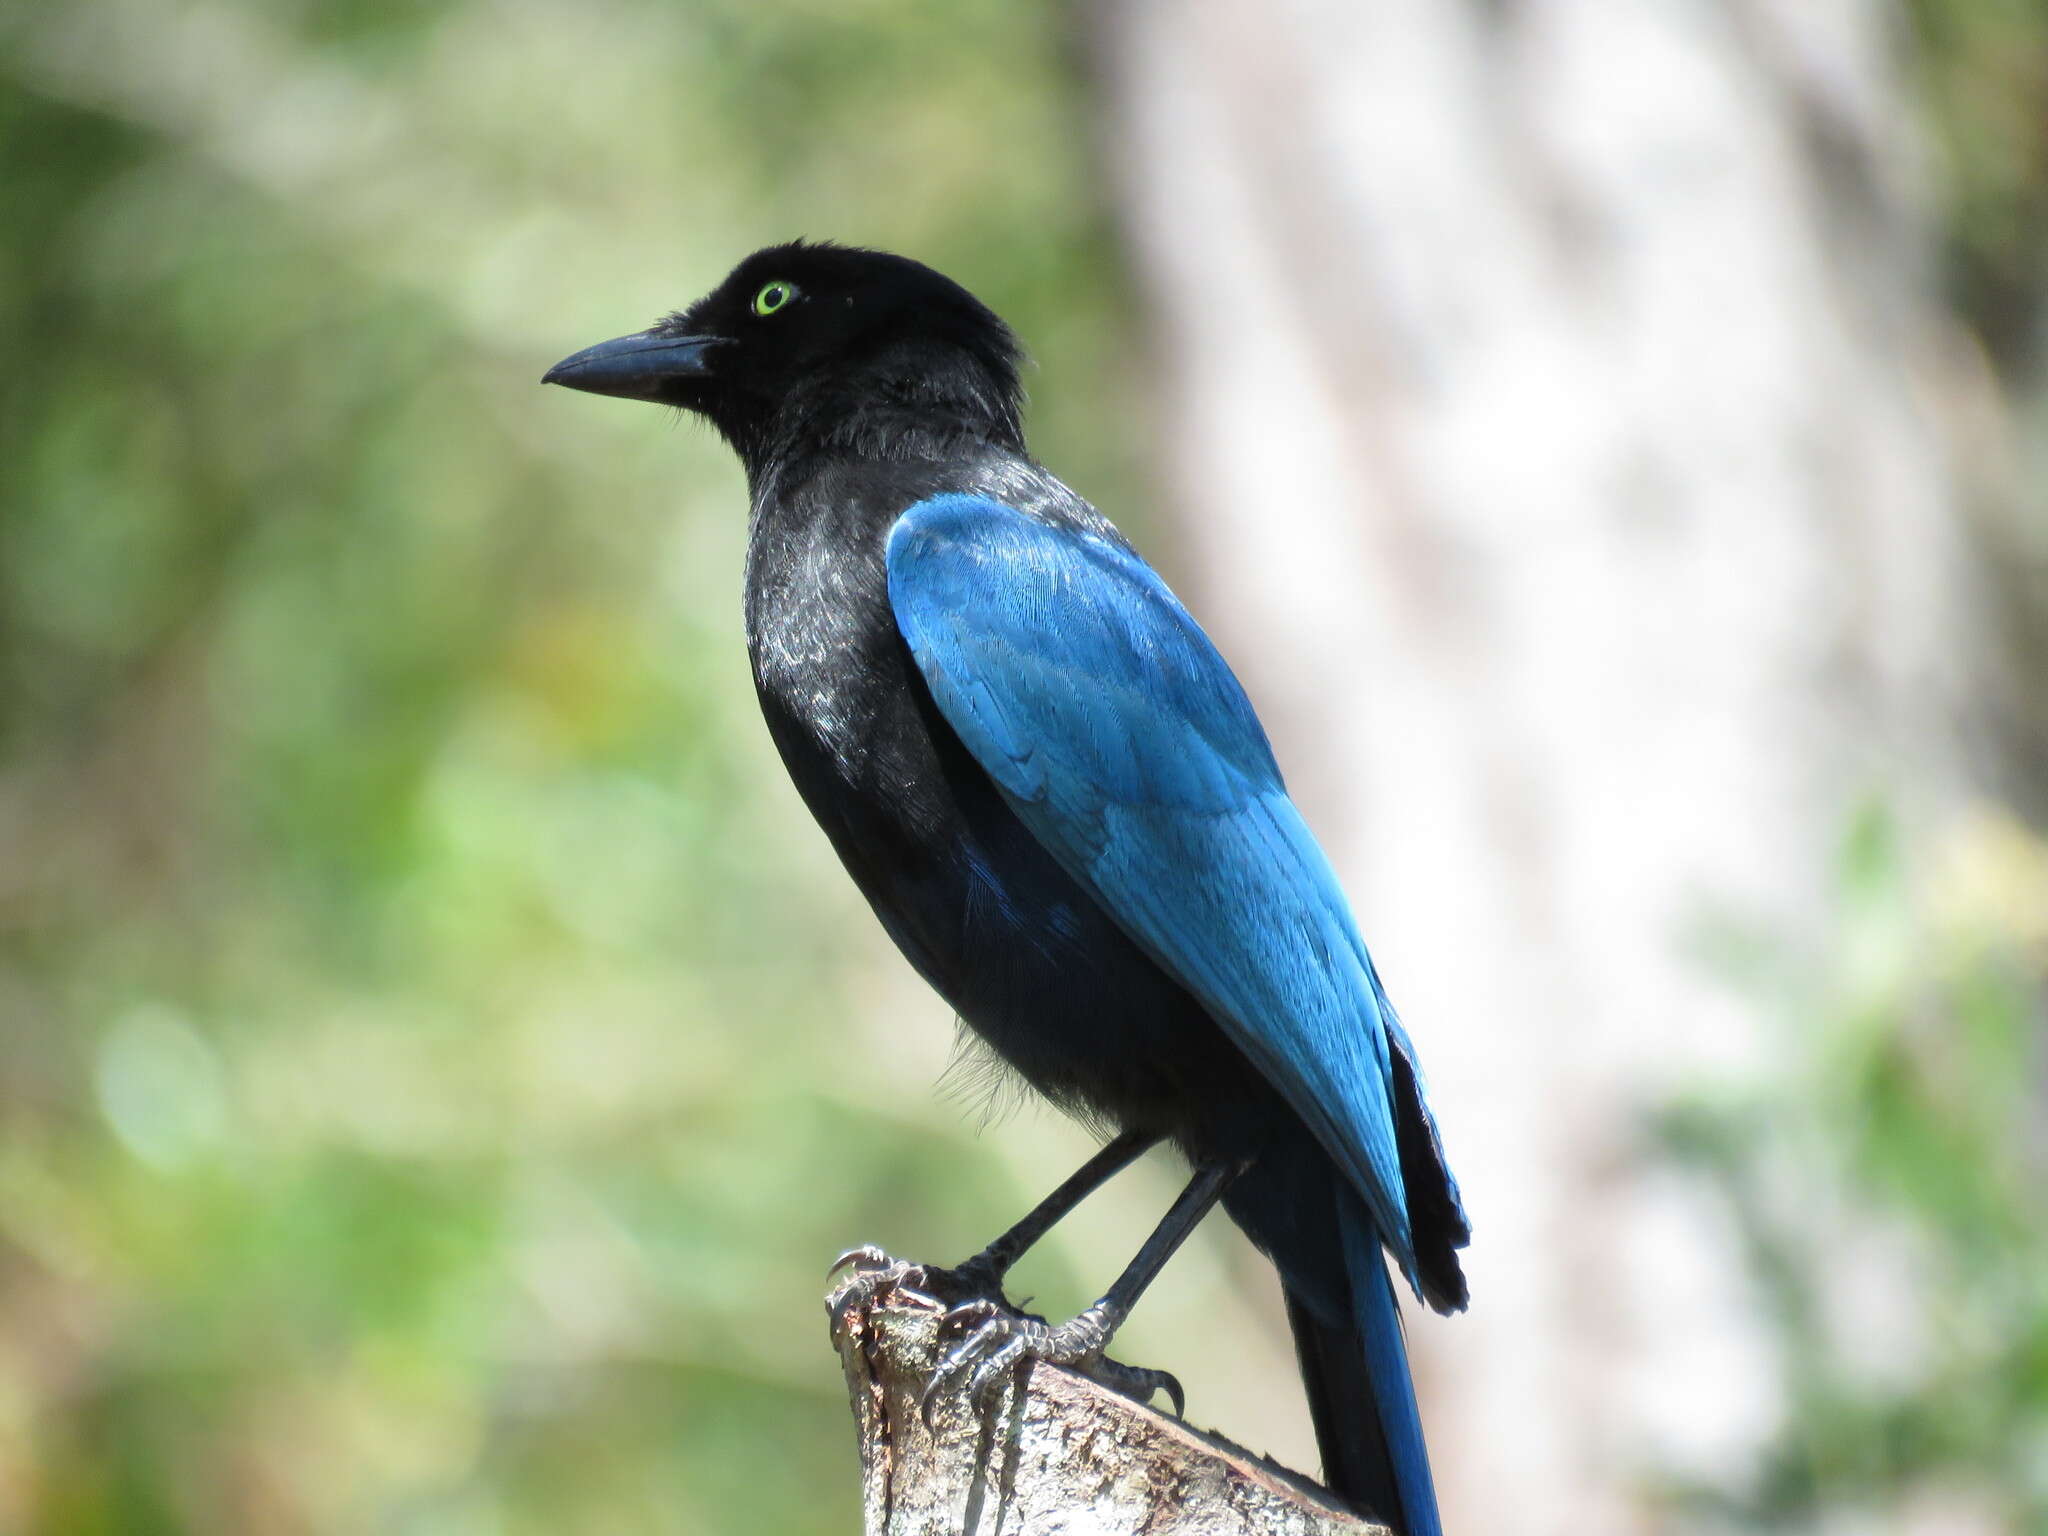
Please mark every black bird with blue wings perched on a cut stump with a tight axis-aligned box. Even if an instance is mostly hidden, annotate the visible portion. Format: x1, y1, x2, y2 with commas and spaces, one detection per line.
543, 240, 1470, 1536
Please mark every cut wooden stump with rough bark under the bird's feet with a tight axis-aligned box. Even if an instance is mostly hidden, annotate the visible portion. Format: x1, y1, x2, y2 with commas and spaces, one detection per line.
827, 1280, 1386, 1536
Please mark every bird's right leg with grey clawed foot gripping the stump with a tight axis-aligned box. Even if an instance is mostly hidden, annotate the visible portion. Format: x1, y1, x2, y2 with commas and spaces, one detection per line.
922, 1163, 1243, 1423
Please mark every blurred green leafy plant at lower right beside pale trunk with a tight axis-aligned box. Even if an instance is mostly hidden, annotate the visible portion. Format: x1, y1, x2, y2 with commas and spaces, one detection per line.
1661, 803, 2048, 1532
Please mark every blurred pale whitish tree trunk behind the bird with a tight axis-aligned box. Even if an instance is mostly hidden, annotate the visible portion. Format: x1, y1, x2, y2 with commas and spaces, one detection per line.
1092, 0, 1972, 1534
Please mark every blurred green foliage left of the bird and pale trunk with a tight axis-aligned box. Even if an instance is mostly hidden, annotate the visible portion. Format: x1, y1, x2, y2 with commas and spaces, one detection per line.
0, 0, 1135, 1536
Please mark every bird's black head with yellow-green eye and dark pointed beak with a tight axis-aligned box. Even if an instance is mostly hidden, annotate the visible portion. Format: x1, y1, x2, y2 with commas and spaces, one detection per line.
543, 240, 1024, 471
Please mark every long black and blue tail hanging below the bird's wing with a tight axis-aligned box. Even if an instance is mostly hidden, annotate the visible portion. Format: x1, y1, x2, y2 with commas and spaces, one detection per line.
1288, 1192, 1444, 1536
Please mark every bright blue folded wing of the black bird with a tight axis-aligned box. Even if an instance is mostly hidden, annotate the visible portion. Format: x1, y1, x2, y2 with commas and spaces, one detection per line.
889, 496, 1415, 1282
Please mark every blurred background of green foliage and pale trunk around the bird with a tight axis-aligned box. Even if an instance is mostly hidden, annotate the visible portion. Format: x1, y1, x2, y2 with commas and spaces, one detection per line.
0, 0, 2048, 1536
